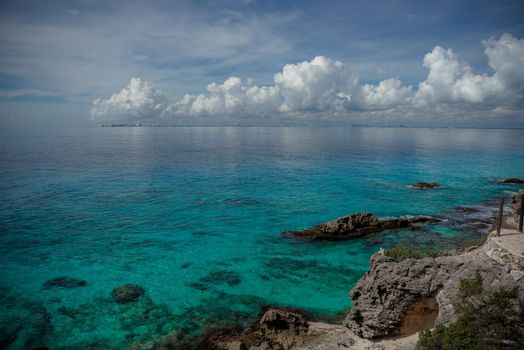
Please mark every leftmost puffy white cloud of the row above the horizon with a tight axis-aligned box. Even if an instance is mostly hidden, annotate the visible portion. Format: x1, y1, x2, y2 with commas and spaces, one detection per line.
90, 78, 167, 121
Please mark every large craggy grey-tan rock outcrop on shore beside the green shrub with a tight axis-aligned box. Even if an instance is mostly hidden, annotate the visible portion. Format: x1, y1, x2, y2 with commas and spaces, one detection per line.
345, 240, 524, 338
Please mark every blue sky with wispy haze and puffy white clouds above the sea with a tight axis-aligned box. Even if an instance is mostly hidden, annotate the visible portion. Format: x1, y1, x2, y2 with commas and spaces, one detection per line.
0, 0, 524, 127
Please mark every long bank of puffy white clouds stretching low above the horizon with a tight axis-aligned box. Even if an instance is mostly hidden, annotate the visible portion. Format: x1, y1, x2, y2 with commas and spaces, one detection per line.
90, 33, 524, 123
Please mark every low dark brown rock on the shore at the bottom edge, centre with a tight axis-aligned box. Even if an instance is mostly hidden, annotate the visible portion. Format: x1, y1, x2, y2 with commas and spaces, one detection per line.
201, 308, 309, 350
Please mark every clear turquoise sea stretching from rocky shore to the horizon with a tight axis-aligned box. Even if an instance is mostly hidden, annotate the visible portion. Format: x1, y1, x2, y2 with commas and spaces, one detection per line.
0, 128, 524, 349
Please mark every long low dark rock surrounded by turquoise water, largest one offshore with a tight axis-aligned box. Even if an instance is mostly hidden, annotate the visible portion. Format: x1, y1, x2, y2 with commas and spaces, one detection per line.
283, 213, 437, 241
